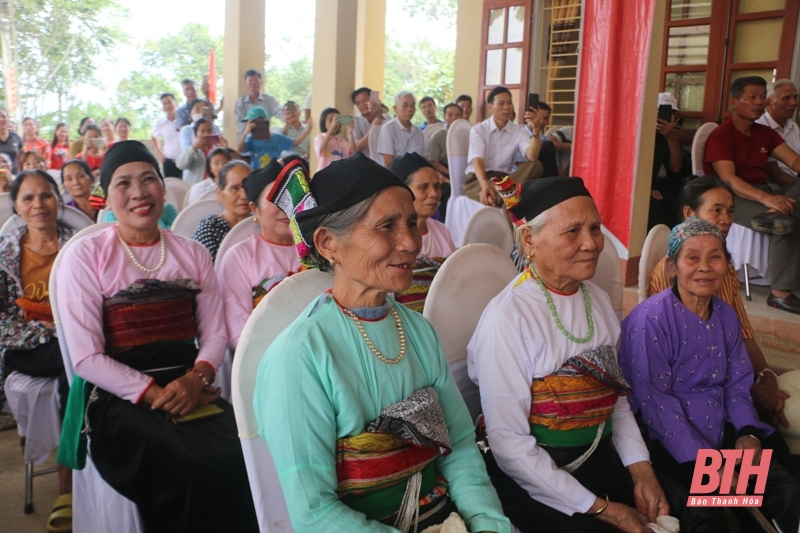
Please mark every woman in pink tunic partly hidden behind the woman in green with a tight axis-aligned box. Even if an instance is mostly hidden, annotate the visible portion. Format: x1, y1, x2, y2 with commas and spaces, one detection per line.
217, 159, 305, 349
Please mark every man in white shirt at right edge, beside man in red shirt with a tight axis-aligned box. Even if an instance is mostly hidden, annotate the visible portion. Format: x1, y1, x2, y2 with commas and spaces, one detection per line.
756, 79, 800, 181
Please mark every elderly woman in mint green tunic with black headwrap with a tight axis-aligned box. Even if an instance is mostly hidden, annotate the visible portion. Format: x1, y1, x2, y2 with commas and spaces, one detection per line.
255, 153, 510, 533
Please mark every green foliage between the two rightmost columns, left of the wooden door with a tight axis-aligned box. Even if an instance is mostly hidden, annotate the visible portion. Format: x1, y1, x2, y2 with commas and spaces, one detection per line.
381, 37, 455, 124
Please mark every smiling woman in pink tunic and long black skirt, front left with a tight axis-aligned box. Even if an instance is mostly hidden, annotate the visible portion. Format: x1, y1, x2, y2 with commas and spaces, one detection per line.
56, 141, 258, 531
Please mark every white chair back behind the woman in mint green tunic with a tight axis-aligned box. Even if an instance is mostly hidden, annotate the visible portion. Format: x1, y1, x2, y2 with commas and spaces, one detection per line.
231, 270, 333, 533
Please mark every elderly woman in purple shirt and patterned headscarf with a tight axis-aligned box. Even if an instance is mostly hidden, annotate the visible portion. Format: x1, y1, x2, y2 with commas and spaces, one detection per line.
619, 218, 800, 531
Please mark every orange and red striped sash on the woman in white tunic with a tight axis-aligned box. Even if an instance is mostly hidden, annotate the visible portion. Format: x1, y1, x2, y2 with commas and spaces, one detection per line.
528, 346, 630, 432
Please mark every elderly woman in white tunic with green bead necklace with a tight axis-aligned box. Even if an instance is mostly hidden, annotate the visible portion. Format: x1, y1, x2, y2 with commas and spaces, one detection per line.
467, 176, 716, 533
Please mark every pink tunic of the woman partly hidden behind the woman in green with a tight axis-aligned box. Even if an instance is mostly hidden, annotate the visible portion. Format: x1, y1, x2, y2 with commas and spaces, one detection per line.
217, 235, 300, 349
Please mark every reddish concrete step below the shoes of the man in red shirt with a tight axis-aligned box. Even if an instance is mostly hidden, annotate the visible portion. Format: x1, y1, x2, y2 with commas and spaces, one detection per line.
622, 285, 800, 358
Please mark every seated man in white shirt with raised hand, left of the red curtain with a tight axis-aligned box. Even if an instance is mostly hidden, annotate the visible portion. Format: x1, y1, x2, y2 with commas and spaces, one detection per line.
463, 87, 542, 207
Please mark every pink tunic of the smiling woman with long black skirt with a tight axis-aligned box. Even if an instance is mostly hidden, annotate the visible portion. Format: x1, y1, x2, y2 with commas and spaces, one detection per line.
56, 225, 228, 403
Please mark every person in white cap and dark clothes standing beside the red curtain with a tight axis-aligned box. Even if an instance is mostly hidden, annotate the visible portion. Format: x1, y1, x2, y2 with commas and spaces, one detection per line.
647, 93, 692, 231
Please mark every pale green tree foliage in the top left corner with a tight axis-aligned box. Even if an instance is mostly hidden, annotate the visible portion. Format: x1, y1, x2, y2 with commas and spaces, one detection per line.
7, 0, 127, 116
